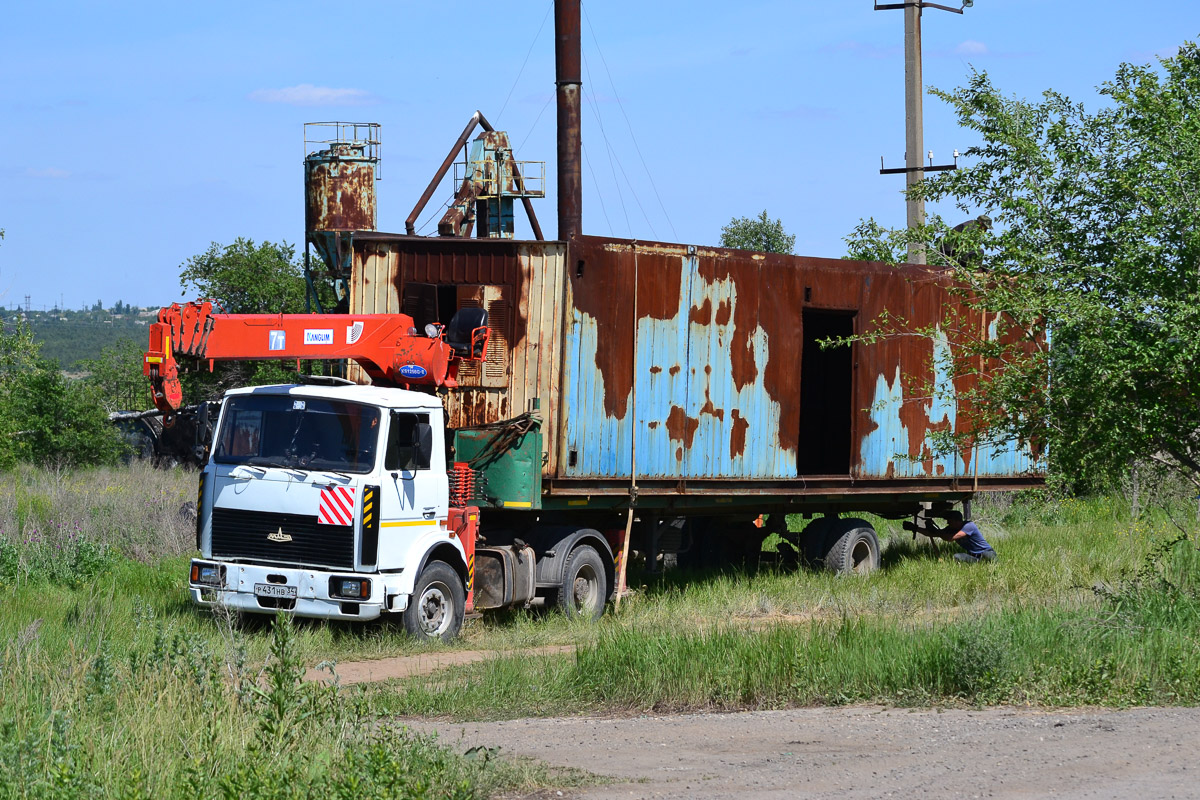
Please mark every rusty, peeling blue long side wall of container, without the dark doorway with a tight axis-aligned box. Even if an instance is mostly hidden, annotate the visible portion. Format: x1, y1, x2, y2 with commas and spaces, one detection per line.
558, 236, 1037, 480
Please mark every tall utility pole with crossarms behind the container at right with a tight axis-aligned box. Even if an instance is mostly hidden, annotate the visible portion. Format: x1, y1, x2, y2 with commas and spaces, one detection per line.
875, 0, 974, 264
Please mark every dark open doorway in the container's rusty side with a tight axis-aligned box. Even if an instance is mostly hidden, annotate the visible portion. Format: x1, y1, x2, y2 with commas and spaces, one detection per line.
798, 309, 854, 475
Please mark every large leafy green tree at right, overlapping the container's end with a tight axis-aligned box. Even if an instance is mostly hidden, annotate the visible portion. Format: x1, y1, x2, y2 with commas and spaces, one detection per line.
847, 43, 1200, 487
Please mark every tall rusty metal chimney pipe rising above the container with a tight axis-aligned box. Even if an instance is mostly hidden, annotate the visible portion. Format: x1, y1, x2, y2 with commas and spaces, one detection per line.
554, 0, 583, 241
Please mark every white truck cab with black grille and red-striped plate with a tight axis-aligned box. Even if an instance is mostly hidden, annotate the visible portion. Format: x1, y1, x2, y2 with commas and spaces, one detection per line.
190, 385, 478, 639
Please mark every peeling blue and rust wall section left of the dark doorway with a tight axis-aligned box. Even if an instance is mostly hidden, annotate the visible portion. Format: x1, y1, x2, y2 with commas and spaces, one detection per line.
563, 239, 798, 480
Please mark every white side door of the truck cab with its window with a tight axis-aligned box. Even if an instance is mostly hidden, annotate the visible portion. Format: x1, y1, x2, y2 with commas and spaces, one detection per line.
379, 409, 446, 570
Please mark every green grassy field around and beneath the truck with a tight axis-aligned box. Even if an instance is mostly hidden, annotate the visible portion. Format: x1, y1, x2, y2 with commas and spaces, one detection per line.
0, 465, 1200, 799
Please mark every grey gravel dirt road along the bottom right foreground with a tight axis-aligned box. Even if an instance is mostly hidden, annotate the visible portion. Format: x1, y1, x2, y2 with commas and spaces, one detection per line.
409, 708, 1200, 800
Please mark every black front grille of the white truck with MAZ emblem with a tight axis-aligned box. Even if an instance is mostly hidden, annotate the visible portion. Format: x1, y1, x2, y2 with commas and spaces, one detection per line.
212, 509, 354, 570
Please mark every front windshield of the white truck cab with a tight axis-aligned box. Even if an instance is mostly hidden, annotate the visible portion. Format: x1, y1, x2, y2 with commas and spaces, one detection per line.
212, 395, 379, 474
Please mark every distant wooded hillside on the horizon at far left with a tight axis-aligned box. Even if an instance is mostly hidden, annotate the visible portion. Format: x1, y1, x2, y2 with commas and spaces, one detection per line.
0, 309, 154, 371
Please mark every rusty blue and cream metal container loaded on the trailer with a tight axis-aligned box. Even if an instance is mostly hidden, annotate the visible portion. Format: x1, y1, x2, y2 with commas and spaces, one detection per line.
348, 231, 1042, 513
